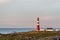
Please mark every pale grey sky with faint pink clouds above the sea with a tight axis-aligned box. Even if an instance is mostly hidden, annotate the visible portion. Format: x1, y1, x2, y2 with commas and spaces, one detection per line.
0, 0, 60, 28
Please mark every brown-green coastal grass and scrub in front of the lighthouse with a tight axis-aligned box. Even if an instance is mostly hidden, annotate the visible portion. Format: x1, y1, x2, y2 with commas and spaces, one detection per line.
0, 31, 60, 40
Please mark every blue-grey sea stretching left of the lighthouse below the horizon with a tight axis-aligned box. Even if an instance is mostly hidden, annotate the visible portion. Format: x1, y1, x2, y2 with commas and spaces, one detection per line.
0, 28, 36, 34
